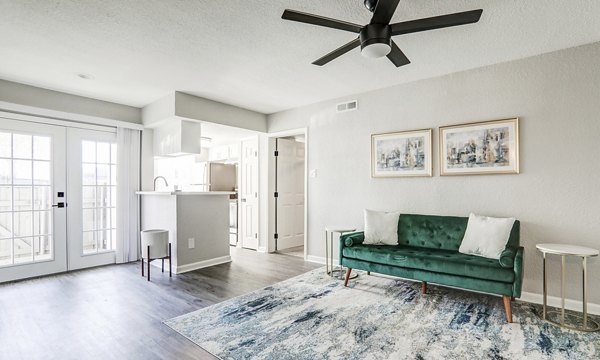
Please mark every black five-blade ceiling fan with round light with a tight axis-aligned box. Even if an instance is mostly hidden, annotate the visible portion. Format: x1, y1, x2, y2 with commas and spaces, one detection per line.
281, 0, 483, 67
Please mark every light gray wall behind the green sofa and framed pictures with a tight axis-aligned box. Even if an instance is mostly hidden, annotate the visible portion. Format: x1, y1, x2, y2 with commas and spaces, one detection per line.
268, 43, 600, 304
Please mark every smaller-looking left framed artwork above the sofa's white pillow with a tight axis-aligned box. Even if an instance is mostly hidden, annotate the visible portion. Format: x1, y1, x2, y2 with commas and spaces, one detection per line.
371, 129, 432, 177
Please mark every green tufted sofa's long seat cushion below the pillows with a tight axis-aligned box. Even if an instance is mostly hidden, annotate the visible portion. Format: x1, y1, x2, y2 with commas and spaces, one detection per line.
343, 245, 515, 283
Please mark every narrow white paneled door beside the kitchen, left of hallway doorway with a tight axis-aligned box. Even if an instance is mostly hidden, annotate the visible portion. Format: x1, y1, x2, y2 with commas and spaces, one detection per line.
239, 137, 258, 250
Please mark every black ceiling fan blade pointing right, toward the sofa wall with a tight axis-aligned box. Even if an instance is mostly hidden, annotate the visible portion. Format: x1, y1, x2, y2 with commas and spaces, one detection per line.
390, 9, 483, 36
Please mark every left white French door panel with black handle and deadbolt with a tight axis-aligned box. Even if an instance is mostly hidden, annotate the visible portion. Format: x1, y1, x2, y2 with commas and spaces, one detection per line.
0, 118, 67, 282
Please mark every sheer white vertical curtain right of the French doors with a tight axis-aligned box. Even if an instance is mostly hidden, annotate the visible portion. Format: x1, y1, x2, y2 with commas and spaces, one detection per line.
116, 128, 141, 263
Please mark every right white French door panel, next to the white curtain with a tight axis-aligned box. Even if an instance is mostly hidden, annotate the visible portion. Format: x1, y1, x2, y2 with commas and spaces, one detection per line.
67, 128, 117, 270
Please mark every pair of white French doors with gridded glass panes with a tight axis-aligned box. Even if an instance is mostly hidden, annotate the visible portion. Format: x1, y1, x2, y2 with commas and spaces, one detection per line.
0, 117, 117, 282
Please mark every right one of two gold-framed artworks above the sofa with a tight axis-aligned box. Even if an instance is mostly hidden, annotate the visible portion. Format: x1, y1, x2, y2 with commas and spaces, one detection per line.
439, 118, 519, 175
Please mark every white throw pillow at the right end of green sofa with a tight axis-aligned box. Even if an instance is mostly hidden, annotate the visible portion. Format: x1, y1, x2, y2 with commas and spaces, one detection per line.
458, 213, 515, 260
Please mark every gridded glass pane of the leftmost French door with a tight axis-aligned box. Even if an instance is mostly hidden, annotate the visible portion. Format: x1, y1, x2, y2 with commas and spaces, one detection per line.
0, 132, 53, 266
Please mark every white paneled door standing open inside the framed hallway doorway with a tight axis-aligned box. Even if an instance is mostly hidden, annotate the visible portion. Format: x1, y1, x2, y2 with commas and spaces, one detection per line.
276, 138, 304, 250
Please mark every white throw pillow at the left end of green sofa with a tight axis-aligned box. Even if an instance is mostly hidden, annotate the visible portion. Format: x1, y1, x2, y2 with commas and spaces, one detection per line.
363, 209, 400, 245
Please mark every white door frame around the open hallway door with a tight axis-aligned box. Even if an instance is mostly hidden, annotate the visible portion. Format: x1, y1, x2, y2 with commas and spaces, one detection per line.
267, 128, 308, 260
